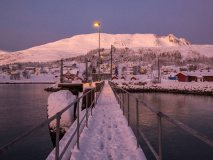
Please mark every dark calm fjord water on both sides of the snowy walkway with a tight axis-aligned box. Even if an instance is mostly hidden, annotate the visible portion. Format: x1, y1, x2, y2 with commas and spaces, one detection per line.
0, 84, 213, 160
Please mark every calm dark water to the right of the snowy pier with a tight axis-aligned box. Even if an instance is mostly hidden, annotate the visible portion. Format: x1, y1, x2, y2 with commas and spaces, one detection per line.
125, 93, 213, 160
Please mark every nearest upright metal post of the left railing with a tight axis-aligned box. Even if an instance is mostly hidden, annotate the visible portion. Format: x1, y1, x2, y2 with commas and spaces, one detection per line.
55, 113, 61, 160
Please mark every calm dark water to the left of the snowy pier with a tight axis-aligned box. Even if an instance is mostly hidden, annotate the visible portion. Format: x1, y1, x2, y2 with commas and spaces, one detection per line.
0, 84, 53, 160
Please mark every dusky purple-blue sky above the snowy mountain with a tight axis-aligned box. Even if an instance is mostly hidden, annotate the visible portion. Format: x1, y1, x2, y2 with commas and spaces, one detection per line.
0, 0, 213, 51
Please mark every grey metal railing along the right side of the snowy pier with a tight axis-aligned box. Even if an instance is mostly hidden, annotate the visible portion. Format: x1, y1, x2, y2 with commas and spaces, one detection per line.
109, 81, 213, 160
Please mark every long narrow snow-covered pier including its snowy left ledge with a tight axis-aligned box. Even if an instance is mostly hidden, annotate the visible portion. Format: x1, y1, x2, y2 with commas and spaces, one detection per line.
47, 82, 146, 160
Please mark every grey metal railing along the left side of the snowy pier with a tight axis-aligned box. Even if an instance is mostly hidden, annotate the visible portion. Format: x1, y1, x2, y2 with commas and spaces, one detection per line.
0, 81, 105, 160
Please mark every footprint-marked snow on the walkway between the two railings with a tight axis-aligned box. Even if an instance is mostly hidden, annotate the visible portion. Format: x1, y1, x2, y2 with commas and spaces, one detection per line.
71, 84, 146, 160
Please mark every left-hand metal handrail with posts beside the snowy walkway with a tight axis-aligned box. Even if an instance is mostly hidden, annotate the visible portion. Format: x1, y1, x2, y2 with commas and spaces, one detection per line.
0, 81, 105, 160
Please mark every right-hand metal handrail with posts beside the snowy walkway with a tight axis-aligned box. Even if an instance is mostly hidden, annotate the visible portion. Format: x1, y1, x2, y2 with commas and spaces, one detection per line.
109, 81, 213, 160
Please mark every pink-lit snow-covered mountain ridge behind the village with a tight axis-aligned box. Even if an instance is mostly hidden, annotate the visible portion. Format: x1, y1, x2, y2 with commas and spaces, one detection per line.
0, 33, 212, 65
